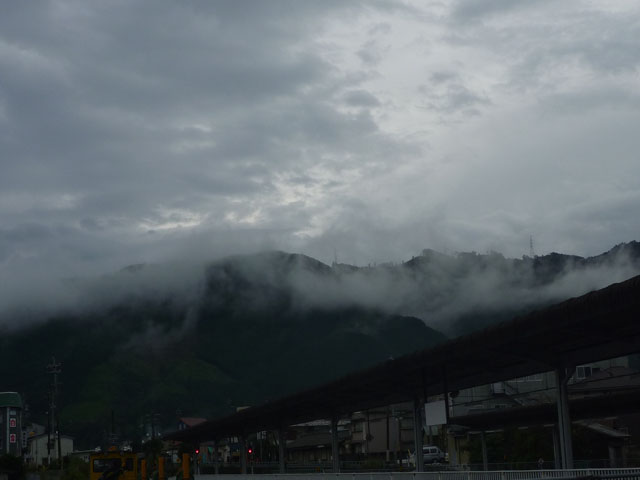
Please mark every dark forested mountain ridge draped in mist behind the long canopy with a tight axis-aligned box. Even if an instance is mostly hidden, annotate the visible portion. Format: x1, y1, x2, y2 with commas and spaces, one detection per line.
0, 242, 640, 448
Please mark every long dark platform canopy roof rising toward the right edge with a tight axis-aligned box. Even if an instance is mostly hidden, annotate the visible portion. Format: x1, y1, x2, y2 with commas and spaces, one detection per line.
165, 276, 640, 441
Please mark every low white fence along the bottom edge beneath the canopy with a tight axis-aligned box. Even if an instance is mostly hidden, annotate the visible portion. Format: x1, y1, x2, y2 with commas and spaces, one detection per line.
195, 468, 640, 480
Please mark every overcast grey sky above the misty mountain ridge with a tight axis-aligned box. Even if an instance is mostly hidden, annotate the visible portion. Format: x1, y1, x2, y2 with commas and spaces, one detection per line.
0, 0, 640, 282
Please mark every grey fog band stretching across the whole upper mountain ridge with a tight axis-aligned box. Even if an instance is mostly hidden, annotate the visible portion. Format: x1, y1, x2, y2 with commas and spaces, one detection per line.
0, 242, 640, 335
